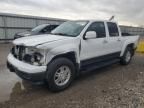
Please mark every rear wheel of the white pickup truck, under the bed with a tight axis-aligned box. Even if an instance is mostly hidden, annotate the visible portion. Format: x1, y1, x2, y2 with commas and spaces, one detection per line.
120, 47, 133, 65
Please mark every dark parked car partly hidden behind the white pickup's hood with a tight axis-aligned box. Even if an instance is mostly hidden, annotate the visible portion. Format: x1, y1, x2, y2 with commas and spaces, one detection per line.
14, 24, 59, 39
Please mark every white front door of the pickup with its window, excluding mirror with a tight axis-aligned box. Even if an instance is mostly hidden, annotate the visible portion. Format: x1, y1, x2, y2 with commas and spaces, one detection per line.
80, 22, 106, 61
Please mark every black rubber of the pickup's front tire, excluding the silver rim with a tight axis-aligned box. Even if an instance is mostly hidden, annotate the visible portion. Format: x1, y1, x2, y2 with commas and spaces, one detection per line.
46, 58, 75, 92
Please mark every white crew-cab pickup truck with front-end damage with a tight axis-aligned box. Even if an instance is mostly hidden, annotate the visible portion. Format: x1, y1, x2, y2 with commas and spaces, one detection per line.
7, 20, 139, 91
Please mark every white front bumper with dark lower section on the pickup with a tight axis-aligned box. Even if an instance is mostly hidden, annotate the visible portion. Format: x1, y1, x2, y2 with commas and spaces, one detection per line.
7, 54, 47, 82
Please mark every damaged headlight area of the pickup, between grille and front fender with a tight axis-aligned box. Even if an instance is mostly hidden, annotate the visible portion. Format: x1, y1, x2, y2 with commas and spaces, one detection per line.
24, 48, 45, 66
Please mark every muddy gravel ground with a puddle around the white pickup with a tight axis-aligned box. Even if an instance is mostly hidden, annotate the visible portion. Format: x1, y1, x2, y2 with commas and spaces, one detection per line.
0, 44, 144, 108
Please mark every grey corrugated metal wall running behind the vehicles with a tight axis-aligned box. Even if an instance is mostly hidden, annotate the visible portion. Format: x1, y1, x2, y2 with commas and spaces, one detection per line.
0, 13, 144, 40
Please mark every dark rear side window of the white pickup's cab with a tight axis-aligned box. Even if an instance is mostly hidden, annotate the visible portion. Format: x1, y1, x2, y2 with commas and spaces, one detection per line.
107, 22, 119, 37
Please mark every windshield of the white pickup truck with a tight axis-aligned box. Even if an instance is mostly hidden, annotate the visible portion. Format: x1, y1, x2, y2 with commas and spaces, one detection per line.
51, 21, 88, 37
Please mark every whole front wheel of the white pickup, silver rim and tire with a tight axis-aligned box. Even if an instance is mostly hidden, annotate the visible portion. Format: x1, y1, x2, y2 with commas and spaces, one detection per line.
47, 58, 75, 92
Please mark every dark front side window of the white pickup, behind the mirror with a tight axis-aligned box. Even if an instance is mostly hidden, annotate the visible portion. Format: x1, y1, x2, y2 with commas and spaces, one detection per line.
87, 22, 106, 38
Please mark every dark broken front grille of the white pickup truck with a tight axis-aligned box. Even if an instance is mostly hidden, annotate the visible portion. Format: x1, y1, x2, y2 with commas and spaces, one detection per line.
11, 45, 25, 60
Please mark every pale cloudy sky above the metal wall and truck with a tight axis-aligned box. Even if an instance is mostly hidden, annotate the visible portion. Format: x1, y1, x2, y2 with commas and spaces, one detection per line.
0, 0, 144, 26
